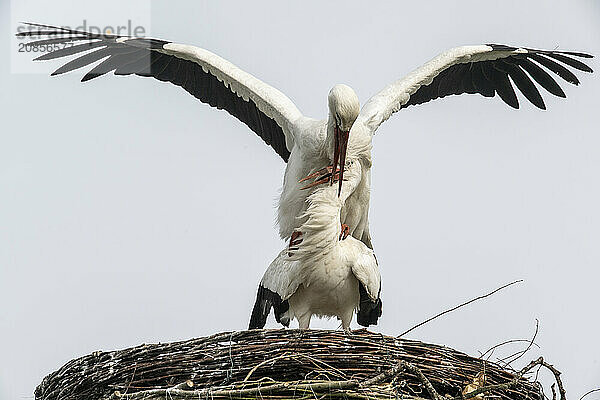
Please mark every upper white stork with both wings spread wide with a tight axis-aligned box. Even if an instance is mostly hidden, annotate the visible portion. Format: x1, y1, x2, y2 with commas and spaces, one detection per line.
17, 24, 592, 258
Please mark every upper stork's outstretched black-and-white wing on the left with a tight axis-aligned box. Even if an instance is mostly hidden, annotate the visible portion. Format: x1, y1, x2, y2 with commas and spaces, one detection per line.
17, 24, 302, 162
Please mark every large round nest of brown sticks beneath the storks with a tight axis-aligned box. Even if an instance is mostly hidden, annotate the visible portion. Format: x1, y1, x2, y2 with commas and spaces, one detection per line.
35, 330, 565, 400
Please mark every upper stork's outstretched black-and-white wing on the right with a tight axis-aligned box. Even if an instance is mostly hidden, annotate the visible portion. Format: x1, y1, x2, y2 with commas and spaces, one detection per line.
358, 44, 592, 132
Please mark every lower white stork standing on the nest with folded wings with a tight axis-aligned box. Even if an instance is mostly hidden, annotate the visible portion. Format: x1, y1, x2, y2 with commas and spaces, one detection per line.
249, 161, 381, 331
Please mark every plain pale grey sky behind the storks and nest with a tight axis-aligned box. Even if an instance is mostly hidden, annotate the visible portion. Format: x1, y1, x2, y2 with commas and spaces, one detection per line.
0, 0, 600, 400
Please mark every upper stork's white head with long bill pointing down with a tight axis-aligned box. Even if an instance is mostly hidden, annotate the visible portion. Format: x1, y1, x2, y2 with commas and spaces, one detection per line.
327, 84, 360, 196
